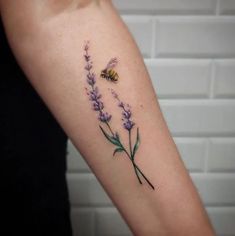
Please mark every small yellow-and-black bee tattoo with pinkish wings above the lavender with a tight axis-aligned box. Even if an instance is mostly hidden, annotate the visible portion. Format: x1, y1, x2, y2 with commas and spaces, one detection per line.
100, 57, 119, 83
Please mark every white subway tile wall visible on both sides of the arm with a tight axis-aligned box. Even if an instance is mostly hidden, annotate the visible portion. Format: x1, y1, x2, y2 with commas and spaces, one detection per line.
65, 0, 235, 236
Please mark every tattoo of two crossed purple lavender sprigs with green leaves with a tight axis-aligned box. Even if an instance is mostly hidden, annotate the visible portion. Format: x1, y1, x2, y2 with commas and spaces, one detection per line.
84, 42, 155, 190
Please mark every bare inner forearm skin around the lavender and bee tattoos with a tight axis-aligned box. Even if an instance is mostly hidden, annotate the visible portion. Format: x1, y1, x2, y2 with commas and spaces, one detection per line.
0, 1, 213, 235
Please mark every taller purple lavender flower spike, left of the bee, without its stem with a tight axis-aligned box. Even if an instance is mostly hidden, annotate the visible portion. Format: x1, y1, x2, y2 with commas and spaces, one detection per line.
84, 42, 112, 123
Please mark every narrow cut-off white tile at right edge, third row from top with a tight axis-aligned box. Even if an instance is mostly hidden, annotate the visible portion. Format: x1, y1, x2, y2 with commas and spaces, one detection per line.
214, 59, 235, 98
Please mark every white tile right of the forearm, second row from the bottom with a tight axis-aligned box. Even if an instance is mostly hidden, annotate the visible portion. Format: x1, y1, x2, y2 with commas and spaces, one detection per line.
191, 173, 235, 206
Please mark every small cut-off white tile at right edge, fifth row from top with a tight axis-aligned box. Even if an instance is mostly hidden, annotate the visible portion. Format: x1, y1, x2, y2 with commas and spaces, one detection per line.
208, 138, 235, 172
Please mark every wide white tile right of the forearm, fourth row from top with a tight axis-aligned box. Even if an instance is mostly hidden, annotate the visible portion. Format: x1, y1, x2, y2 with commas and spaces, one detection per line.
160, 100, 235, 136
